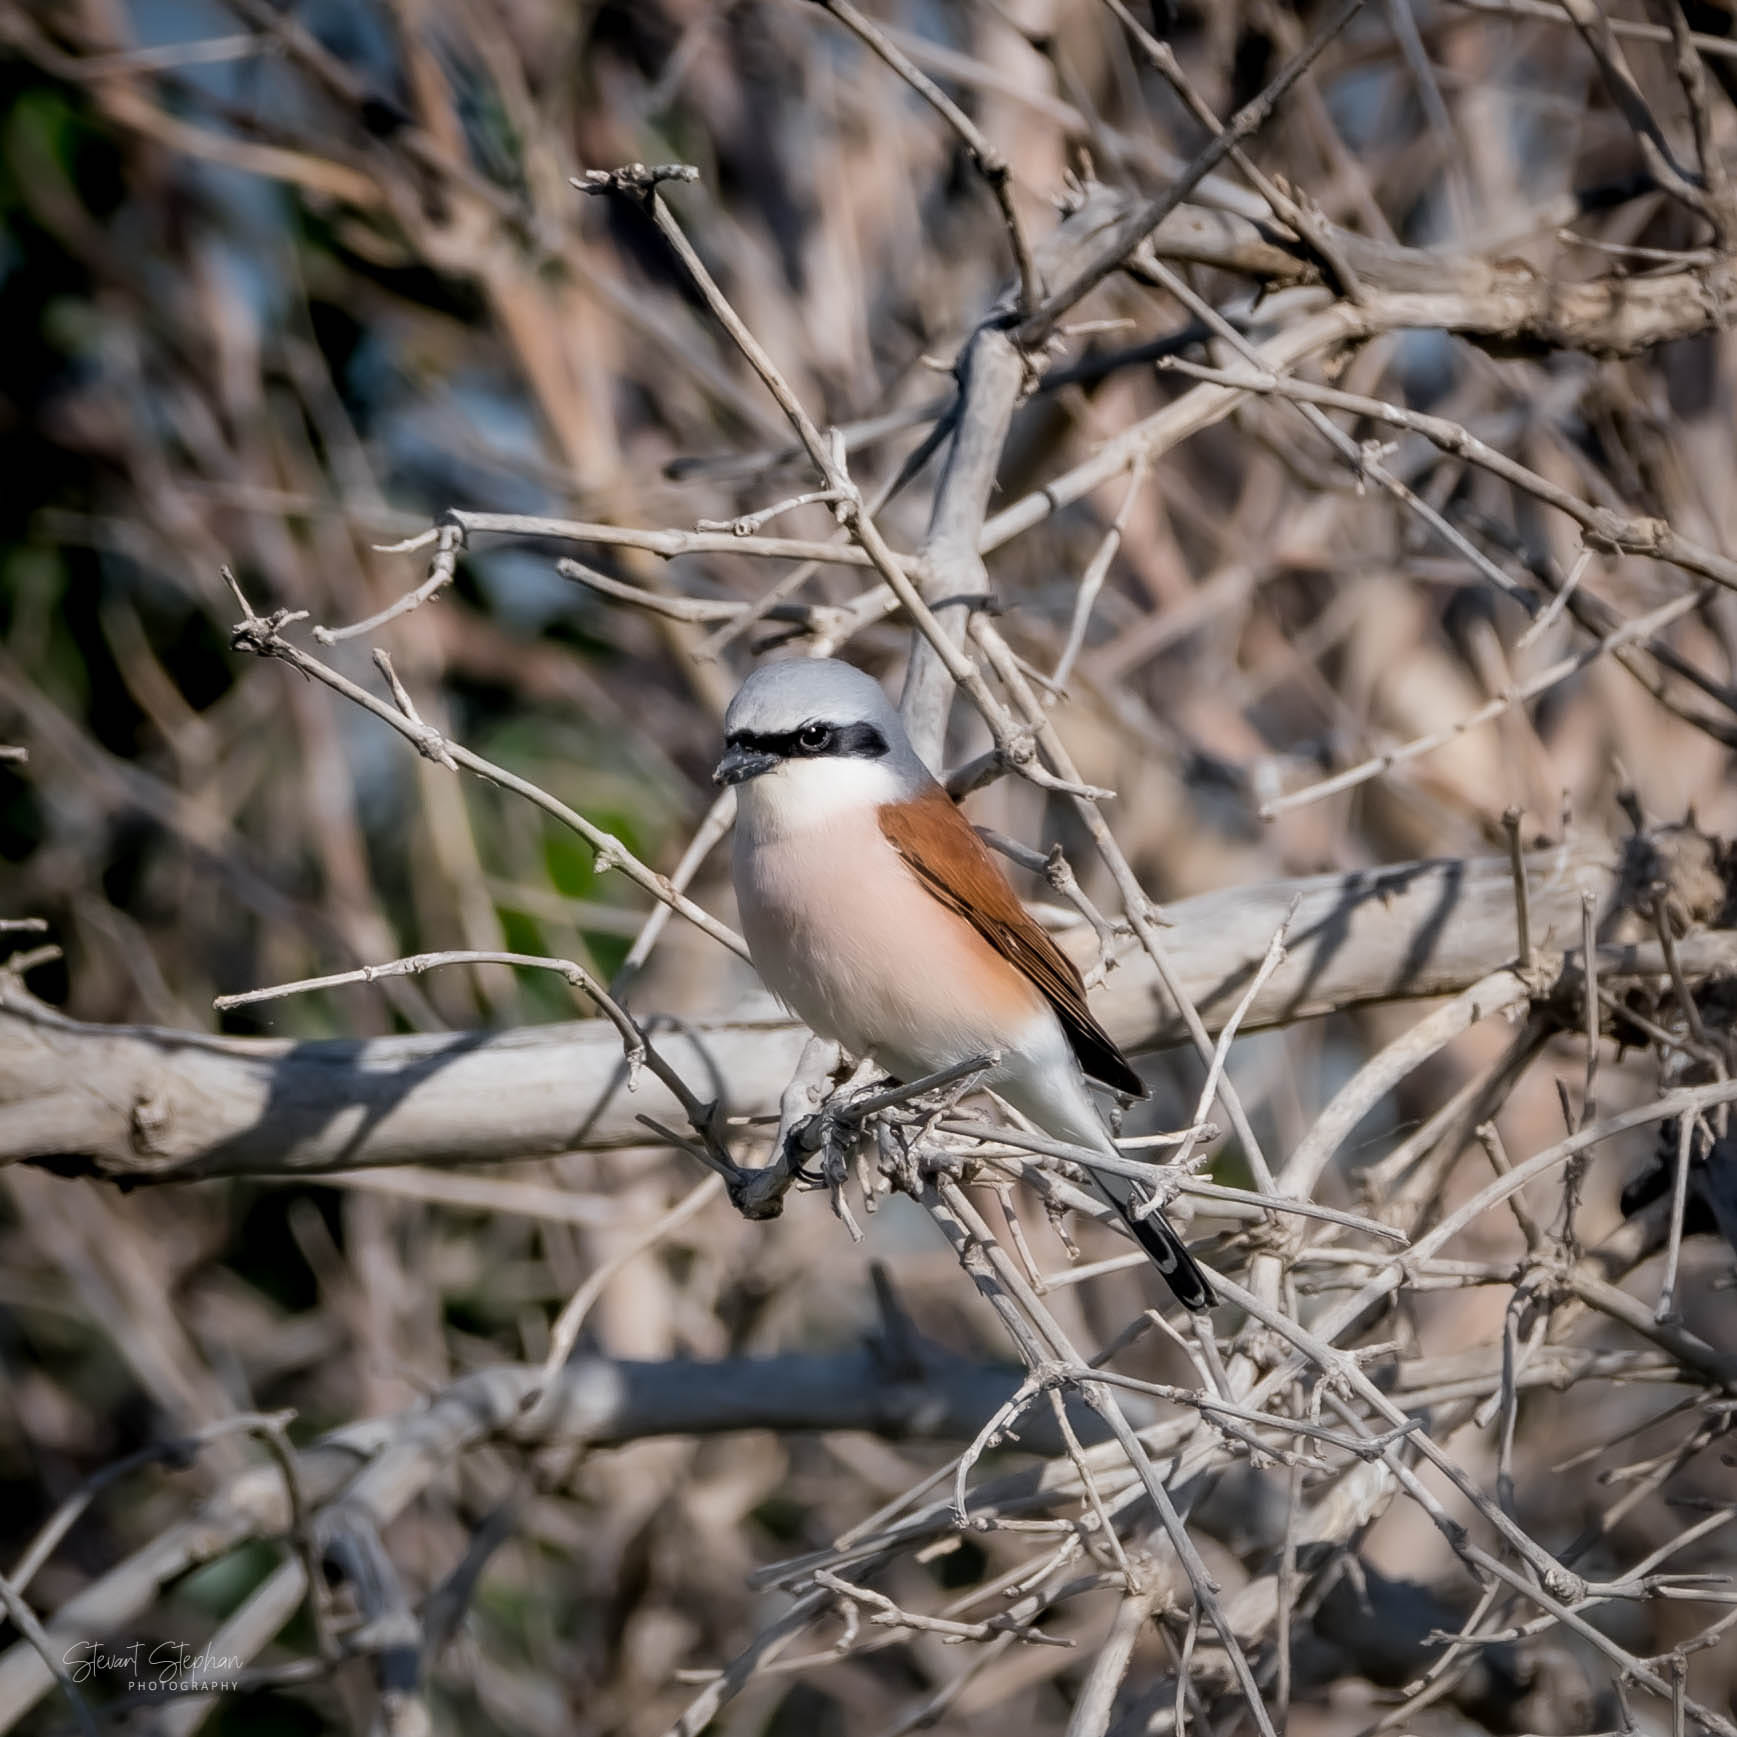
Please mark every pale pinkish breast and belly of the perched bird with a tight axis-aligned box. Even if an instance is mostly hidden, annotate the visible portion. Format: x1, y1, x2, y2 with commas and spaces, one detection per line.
735, 809, 1053, 1079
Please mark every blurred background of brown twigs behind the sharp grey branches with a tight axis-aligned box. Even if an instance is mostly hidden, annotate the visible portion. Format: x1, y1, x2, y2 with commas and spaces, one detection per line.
0, 0, 1737, 1737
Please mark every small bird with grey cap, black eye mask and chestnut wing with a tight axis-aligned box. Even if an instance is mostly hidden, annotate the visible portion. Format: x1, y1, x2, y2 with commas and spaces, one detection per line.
712, 658, 1216, 1311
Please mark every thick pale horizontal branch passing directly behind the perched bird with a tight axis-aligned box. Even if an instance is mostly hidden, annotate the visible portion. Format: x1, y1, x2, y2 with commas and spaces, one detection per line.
0, 826, 1723, 1181
